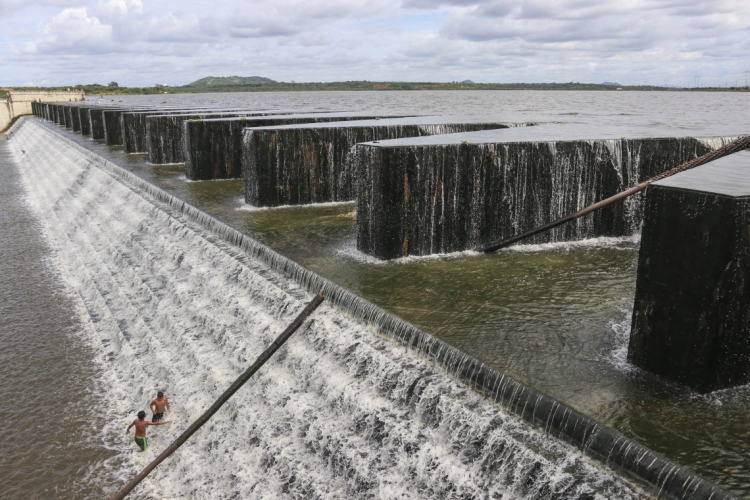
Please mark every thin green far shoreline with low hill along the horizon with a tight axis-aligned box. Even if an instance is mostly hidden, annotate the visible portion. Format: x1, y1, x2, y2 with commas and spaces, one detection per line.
0, 76, 749, 98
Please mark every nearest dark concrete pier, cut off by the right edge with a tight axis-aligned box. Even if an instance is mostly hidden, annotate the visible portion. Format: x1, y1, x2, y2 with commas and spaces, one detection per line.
628, 151, 750, 392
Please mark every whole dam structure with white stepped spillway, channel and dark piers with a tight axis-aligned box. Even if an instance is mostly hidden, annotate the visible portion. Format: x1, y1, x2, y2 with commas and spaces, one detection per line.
5, 93, 750, 500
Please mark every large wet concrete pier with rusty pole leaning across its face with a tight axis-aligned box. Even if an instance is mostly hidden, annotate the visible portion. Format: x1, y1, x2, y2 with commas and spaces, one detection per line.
357, 125, 736, 259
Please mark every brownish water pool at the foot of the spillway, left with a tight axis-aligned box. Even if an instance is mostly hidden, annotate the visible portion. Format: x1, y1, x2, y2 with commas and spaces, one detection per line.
0, 140, 132, 499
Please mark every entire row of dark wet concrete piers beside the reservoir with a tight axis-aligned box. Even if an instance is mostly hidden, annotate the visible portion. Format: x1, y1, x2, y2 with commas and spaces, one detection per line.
32, 101, 750, 406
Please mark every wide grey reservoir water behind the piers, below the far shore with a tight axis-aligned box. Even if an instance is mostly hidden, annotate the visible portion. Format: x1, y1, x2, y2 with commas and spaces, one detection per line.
81, 91, 750, 137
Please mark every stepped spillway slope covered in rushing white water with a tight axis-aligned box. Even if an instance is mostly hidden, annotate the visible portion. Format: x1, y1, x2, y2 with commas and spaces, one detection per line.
11, 120, 731, 499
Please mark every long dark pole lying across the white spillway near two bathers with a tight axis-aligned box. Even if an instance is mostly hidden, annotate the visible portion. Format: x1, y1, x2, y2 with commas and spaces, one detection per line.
112, 293, 324, 500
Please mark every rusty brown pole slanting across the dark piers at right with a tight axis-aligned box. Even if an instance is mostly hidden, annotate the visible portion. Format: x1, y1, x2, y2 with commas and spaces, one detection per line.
479, 135, 750, 253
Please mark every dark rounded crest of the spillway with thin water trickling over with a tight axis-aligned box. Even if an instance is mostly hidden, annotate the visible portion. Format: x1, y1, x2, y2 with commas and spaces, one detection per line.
36, 119, 736, 500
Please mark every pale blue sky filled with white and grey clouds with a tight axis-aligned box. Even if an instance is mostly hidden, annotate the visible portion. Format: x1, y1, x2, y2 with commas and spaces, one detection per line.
0, 0, 750, 87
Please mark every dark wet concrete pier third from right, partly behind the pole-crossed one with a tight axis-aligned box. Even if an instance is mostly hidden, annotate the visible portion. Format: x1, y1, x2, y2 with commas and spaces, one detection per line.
242, 116, 515, 207
